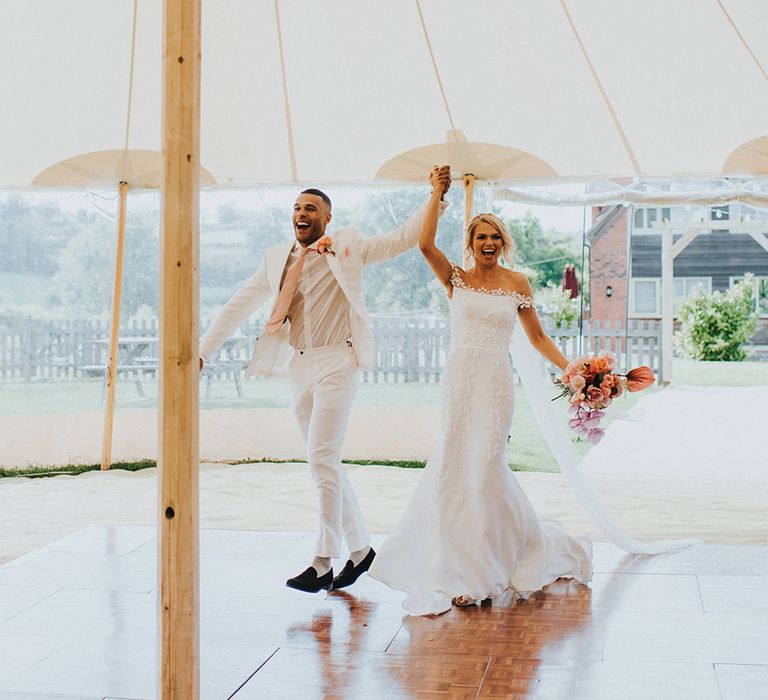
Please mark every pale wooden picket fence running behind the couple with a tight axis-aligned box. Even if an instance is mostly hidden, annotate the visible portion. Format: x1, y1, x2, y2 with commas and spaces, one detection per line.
0, 315, 661, 383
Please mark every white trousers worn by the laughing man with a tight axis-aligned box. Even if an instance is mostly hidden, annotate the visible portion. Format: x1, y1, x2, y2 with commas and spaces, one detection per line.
288, 343, 371, 558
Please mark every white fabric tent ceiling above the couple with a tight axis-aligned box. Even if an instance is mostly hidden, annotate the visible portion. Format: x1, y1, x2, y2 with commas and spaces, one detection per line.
0, 0, 768, 187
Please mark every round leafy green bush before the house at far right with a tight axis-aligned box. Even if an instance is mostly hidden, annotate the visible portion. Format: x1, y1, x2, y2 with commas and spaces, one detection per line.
676, 275, 757, 362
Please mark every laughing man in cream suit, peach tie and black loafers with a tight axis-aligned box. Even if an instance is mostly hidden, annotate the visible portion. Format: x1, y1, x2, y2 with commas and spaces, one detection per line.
200, 166, 451, 593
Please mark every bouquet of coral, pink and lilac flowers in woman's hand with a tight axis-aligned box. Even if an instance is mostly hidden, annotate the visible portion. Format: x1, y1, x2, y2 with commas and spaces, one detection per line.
553, 352, 655, 445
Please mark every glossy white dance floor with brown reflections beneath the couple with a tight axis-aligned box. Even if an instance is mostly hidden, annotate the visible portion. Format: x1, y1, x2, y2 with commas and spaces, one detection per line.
0, 526, 768, 700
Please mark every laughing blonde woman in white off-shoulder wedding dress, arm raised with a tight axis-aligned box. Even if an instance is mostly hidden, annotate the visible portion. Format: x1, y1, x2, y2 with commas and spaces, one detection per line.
368, 183, 592, 615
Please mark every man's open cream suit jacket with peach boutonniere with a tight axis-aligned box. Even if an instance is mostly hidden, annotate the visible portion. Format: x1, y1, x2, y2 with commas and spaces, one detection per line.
200, 198, 448, 377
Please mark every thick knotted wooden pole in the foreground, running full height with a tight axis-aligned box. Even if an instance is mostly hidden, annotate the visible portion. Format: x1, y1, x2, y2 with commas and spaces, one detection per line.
157, 0, 201, 700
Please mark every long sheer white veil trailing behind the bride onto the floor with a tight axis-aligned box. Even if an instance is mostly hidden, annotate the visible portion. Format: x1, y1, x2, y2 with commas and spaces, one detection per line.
511, 323, 700, 554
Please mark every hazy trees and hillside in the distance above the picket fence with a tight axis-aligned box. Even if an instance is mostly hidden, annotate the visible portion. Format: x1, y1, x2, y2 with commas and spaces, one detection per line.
0, 191, 578, 320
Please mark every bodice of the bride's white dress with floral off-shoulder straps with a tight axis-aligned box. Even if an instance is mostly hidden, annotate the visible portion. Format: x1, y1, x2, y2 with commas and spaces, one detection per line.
450, 267, 533, 353
